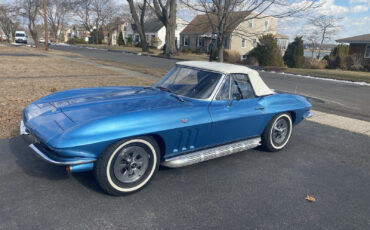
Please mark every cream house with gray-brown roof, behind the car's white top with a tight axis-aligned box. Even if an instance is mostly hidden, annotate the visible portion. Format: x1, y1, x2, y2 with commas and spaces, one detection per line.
180, 11, 289, 59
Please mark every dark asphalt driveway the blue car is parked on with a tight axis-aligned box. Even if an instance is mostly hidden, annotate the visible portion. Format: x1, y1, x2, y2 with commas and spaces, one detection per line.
0, 122, 370, 230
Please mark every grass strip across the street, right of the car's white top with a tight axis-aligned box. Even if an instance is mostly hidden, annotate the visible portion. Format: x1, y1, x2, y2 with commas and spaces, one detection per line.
284, 68, 370, 83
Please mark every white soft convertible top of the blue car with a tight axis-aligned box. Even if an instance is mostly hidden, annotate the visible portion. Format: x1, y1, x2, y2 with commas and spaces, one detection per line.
176, 61, 274, 96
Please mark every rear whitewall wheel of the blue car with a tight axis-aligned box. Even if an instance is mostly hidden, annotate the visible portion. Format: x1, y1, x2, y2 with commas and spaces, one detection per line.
262, 113, 293, 152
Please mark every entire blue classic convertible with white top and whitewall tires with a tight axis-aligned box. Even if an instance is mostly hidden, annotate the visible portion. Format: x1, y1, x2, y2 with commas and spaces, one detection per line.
20, 61, 312, 195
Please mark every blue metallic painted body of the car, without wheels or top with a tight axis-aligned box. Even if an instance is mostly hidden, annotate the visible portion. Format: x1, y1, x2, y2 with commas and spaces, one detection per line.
23, 77, 311, 169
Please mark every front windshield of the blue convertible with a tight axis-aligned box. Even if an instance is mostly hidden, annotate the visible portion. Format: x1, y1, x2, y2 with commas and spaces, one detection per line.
154, 66, 222, 99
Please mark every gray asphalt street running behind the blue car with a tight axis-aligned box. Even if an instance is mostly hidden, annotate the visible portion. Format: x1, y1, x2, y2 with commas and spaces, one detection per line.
51, 43, 370, 121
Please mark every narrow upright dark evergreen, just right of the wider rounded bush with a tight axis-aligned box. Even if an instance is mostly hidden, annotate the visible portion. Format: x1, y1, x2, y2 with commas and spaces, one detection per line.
283, 37, 304, 68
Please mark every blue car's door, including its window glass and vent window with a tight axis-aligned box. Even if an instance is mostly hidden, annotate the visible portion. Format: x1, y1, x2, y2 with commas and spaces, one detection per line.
209, 74, 265, 143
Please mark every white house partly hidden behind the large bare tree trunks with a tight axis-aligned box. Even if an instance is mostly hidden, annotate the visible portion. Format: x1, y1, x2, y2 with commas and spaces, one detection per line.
129, 17, 188, 49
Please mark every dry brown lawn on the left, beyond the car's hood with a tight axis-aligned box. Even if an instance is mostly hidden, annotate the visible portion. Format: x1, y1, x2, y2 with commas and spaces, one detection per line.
0, 47, 154, 138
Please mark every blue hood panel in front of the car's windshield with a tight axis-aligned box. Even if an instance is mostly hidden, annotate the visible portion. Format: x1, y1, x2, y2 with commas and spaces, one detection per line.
50, 87, 180, 123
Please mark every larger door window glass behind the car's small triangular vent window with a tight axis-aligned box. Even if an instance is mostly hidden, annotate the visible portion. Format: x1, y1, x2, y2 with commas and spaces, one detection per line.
231, 74, 255, 99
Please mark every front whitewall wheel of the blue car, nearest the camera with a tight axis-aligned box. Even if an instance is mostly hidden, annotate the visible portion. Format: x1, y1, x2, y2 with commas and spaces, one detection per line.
94, 136, 160, 196
